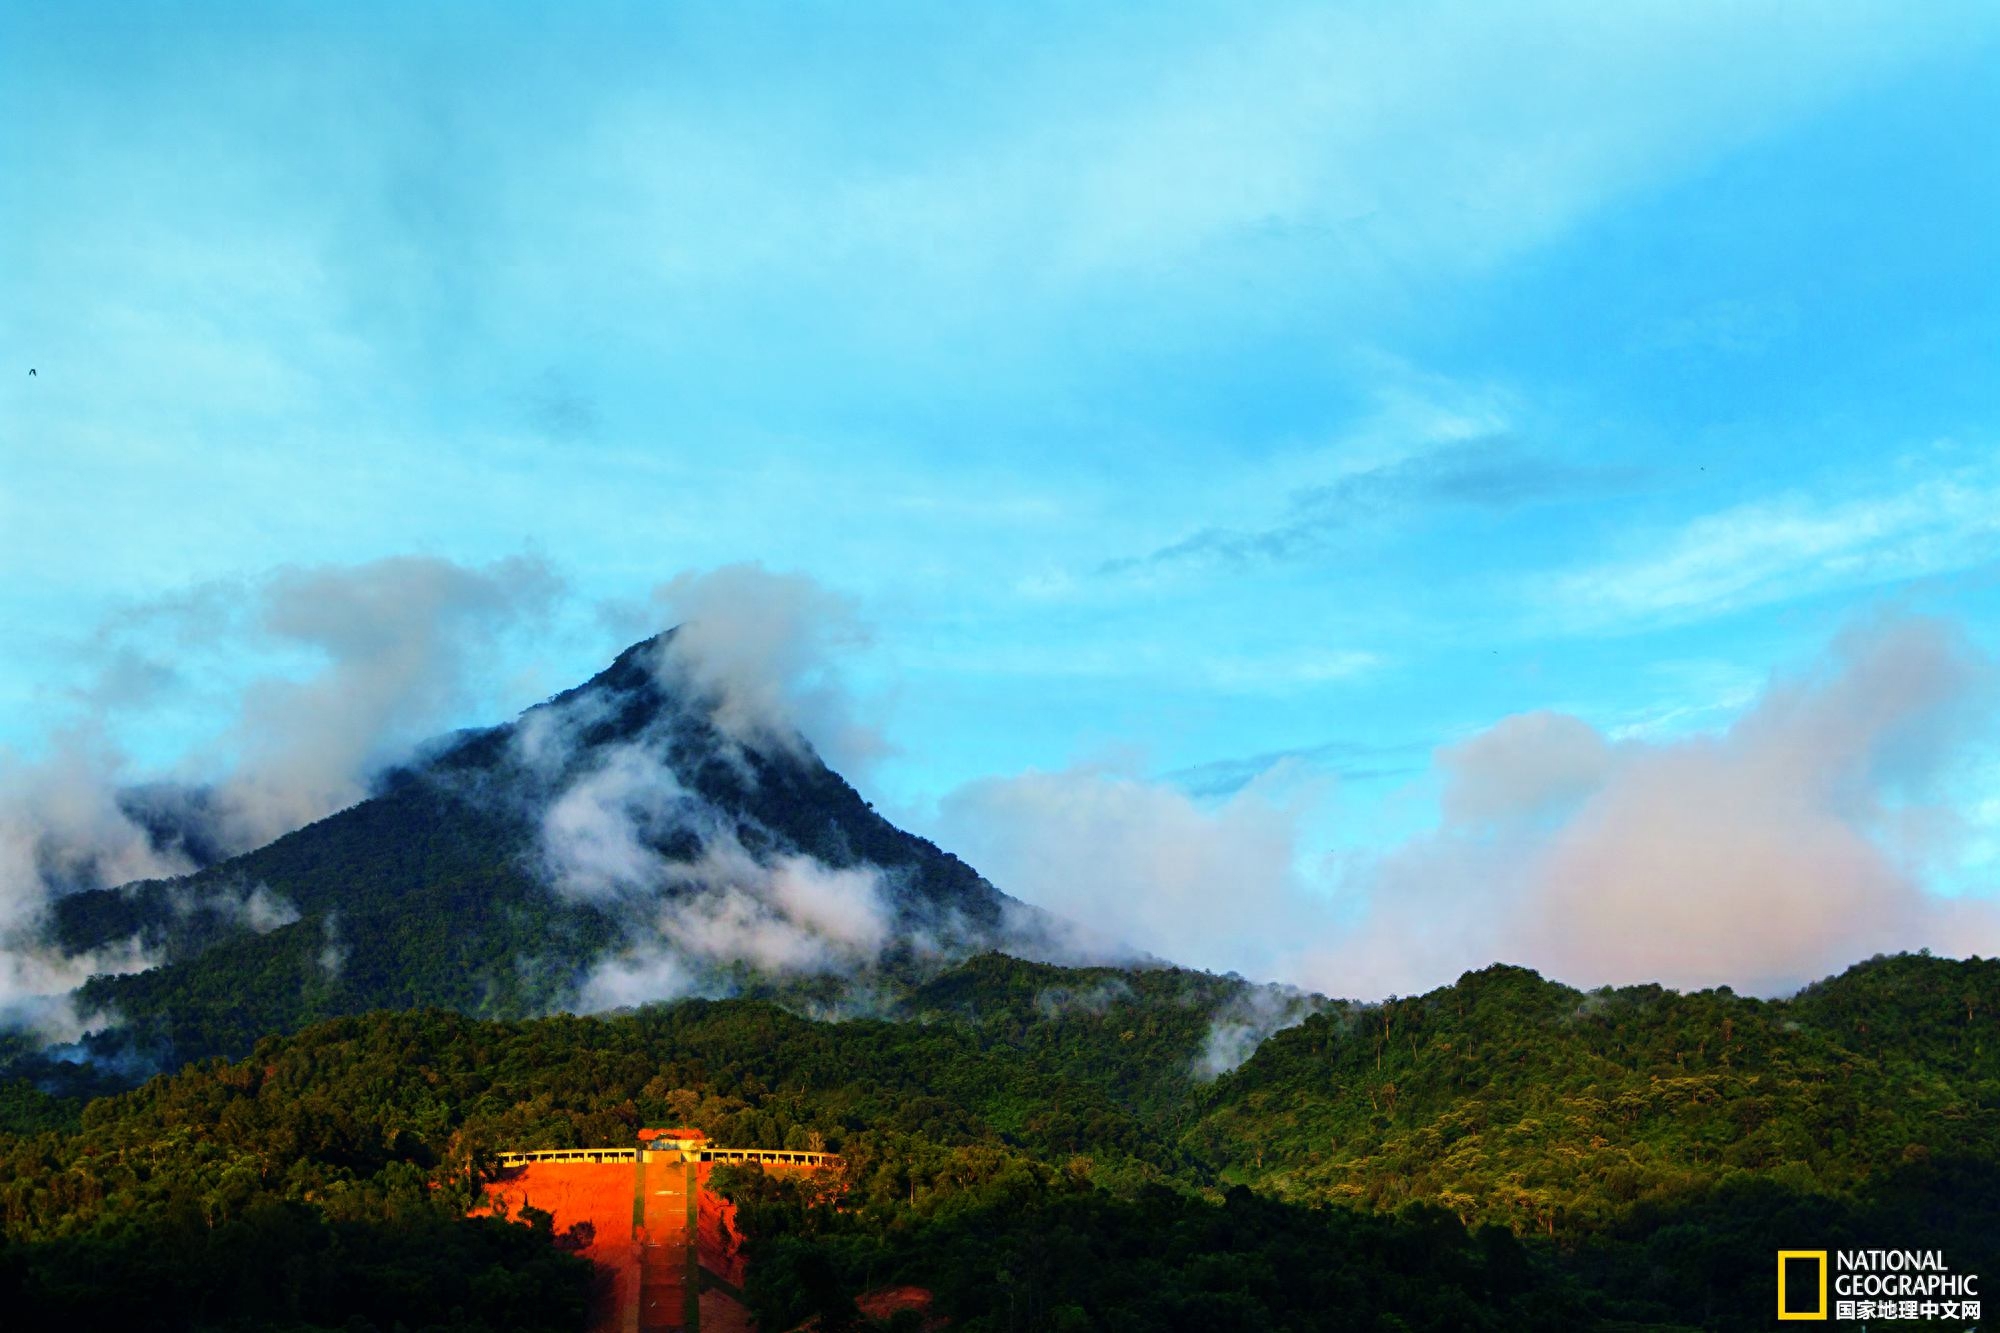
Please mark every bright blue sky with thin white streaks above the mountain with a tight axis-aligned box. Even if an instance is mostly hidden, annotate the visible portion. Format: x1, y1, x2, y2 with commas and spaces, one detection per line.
0, 4, 2000, 987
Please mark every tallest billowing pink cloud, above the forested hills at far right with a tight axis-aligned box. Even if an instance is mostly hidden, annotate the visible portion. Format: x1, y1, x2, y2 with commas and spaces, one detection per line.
1294, 620, 2000, 993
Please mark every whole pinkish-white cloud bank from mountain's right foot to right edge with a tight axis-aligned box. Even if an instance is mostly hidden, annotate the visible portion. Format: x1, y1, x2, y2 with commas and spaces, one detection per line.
938, 618, 2000, 996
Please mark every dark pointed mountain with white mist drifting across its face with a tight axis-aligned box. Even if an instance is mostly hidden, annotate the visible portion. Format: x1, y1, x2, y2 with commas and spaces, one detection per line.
52, 632, 1038, 1065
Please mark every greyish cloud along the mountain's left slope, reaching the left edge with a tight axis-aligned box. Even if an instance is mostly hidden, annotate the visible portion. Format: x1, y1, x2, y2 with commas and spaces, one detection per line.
0, 556, 560, 1029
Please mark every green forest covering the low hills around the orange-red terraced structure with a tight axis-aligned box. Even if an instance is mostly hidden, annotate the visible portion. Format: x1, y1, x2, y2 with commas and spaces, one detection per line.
0, 955, 2000, 1333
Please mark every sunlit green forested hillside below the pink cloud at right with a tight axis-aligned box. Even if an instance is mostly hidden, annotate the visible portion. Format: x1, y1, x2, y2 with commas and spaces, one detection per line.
1190, 957, 2000, 1233
